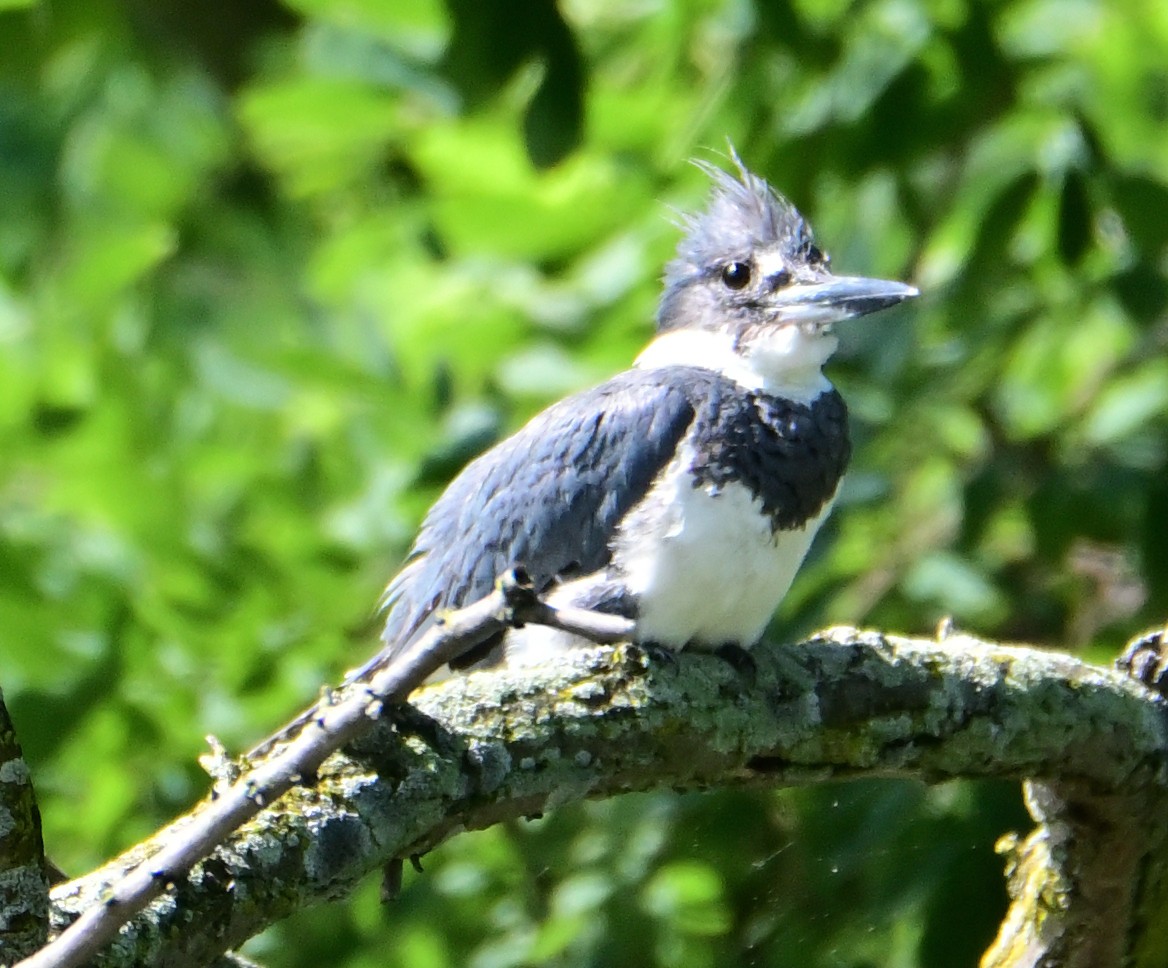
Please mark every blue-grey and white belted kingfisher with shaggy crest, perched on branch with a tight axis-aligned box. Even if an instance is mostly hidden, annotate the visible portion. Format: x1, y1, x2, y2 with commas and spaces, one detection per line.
380, 155, 918, 668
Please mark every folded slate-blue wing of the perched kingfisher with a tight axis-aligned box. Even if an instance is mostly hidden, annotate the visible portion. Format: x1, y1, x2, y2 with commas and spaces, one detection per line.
382, 370, 694, 656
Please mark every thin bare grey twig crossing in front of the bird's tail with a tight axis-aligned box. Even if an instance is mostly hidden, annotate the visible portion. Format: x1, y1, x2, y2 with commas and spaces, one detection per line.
18, 572, 633, 968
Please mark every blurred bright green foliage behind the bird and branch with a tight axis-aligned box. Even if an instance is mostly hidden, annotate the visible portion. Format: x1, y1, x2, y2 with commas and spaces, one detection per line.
0, 0, 1168, 968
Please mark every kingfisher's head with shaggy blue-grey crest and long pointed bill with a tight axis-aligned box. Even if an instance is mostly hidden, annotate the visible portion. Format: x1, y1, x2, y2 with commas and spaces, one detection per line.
658, 155, 918, 392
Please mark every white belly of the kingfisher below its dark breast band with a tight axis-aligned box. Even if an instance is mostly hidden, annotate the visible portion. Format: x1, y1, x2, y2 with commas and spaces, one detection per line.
613, 461, 832, 648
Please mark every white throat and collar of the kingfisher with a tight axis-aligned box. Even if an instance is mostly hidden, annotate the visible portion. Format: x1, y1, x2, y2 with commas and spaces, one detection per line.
635, 325, 837, 404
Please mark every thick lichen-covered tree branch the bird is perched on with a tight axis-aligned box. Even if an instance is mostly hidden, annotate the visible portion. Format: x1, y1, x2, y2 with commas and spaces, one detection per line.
34, 629, 1168, 966
